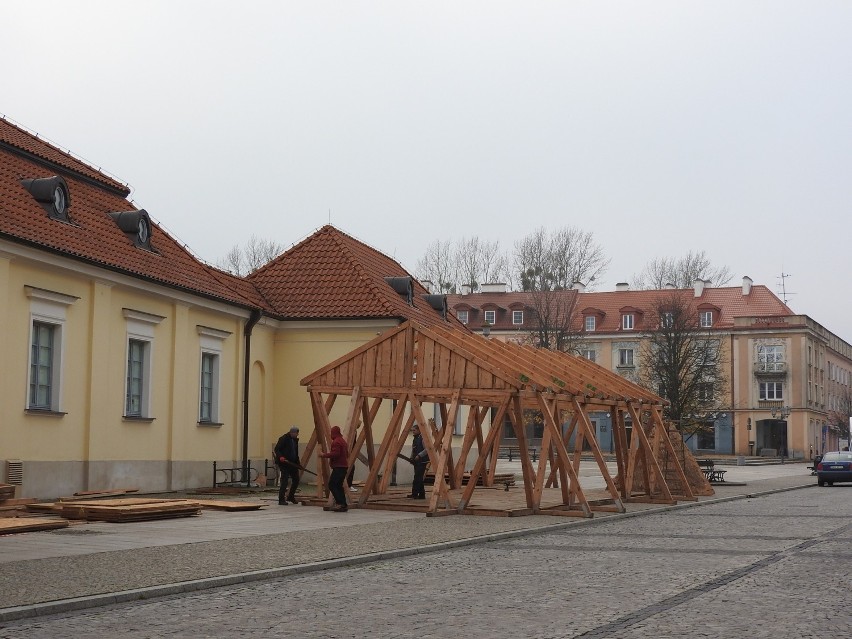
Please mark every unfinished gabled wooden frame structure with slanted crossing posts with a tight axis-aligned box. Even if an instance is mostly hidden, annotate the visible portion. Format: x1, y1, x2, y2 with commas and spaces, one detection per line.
301, 321, 696, 517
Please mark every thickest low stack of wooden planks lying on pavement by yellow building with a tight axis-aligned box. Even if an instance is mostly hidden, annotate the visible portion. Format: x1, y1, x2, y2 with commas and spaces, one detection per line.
58, 497, 201, 523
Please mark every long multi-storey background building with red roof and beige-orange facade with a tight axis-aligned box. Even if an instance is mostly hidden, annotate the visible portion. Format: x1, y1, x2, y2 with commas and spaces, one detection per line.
448, 277, 852, 459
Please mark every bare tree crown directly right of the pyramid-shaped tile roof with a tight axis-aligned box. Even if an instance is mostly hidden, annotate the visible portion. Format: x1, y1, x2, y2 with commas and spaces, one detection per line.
416, 237, 509, 293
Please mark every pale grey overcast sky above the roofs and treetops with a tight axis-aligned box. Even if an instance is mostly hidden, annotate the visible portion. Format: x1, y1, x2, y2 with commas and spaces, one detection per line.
6, 0, 852, 342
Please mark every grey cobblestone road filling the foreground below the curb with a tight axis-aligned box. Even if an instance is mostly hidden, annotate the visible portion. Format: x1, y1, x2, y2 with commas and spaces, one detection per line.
0, 485, 852, 639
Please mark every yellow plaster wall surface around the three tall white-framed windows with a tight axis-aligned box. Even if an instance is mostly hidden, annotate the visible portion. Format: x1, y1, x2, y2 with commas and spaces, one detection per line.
0, 252, 247, 462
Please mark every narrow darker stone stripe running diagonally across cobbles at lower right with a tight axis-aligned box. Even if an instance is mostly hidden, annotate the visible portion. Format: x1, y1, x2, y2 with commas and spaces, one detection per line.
574, 524, 852, 639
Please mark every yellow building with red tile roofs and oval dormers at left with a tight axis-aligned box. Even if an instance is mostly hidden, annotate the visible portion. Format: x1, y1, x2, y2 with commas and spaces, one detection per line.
0, 119, 458, 497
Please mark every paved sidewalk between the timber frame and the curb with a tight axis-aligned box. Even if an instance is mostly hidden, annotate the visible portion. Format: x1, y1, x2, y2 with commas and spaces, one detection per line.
0, 463, 816, 622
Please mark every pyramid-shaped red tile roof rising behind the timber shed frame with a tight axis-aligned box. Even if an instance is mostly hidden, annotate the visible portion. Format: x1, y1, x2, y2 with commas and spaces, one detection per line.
247, 225, 466, 326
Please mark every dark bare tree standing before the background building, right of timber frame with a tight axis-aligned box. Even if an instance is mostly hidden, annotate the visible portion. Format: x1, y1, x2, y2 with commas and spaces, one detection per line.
639, 290, 726, 444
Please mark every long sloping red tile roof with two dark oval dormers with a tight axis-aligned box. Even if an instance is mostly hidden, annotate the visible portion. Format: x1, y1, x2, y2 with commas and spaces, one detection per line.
0, 118, 264, 307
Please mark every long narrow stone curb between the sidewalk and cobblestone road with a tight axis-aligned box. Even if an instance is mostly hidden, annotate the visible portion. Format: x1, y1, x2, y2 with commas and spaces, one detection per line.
0, 483, 816, 623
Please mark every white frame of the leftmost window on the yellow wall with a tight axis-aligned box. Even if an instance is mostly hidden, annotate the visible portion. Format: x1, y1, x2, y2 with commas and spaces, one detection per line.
24, 286, 80, 413
